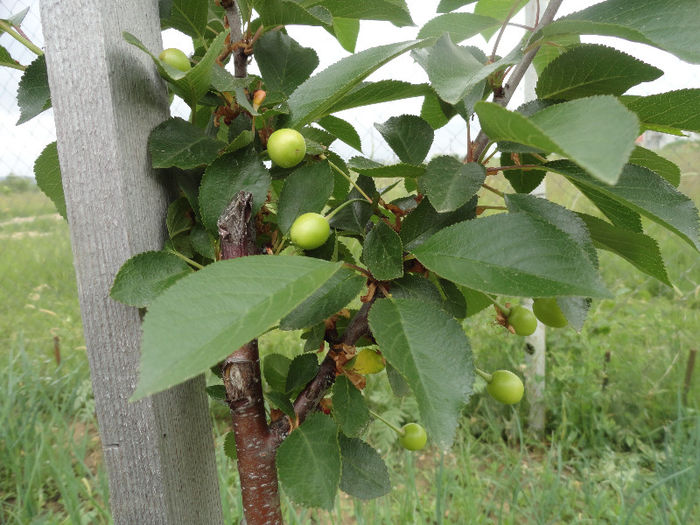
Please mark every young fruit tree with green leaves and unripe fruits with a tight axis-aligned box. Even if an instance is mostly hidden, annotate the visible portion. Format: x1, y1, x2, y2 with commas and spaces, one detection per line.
6, 0, 700, 525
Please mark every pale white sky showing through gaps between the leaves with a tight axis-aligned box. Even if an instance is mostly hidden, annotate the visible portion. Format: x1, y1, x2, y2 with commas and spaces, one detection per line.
0, 0, 700, 177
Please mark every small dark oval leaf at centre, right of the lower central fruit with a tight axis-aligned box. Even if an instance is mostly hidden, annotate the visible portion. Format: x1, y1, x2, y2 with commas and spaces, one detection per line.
362, 221, 403, 281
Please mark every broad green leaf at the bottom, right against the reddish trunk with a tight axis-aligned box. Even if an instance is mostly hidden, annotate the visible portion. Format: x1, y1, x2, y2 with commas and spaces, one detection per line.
276, 412, 341, 509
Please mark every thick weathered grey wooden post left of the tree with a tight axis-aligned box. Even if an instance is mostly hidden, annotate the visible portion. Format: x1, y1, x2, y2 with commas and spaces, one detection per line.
41, 0, 223, 525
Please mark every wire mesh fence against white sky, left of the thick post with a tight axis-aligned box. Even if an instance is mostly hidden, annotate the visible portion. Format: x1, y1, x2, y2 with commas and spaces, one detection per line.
0, 0, 56, 178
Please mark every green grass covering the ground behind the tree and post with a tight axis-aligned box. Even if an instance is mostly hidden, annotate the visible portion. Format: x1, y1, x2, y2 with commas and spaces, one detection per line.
0, 150, 700, 525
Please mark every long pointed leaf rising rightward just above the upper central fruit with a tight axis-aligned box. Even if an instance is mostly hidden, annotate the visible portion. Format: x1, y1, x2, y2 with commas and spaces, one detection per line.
289, 40, 423, 128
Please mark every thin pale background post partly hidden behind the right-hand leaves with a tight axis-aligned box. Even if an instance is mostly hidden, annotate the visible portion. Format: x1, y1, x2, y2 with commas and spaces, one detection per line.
523, 1, 547, 439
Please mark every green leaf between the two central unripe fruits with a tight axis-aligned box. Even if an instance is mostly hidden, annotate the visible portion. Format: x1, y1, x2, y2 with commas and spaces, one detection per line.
277, 162, 333, 234
